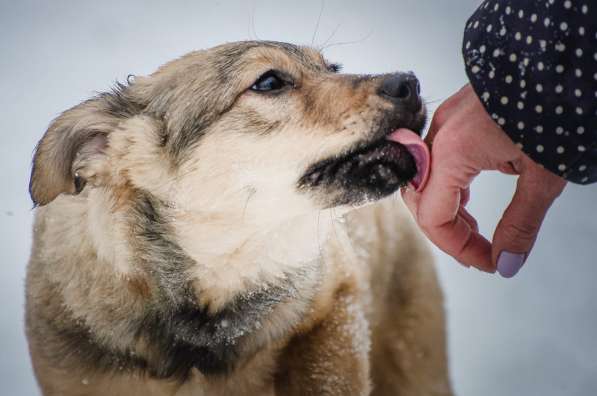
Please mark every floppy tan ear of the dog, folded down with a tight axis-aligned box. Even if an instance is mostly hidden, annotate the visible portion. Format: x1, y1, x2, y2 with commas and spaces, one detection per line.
29, 93, 130, 205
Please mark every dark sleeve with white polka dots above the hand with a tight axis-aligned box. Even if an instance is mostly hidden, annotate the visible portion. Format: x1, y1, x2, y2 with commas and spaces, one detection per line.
463, 0, 597, 184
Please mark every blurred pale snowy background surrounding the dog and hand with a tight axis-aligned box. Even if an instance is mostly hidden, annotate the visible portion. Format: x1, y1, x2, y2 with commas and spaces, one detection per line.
0, 0, 597, 396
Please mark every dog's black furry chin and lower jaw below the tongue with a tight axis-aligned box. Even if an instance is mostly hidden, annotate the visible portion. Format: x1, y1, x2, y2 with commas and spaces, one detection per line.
299, 134, 417, 208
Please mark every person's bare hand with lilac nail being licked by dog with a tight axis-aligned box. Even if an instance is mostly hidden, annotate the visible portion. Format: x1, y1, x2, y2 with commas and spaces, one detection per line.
402, 85, 566, 278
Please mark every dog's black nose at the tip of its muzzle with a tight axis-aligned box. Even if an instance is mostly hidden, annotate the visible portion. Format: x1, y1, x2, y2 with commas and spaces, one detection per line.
380, 73, 422, 112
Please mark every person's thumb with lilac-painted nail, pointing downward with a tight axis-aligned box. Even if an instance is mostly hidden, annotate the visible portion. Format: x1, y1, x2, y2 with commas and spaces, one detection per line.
492, 157, 566, 278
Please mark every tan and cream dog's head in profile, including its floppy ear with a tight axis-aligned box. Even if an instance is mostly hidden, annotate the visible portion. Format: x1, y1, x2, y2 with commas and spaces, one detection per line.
30, 42, 425, 224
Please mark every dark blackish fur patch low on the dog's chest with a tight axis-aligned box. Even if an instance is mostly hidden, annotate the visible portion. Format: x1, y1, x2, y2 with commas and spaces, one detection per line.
139, 287, 289, 380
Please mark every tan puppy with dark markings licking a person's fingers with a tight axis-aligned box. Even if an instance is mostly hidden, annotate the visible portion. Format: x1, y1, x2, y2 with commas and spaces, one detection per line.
26, 41, 451, 396
